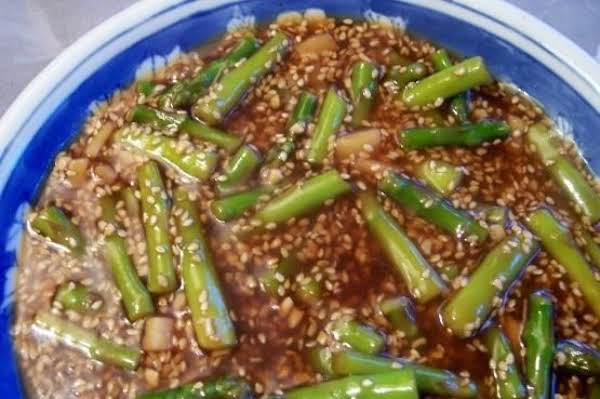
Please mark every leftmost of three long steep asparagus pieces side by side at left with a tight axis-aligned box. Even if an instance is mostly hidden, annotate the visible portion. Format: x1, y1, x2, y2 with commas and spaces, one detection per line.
100, 196, 154, 322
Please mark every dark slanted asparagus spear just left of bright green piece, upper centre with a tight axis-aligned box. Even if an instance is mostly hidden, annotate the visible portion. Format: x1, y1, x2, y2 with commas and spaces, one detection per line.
260, 91, 319, 185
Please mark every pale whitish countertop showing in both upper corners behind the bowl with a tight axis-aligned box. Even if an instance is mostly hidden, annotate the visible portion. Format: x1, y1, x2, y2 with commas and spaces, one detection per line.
0, 0, 600, 115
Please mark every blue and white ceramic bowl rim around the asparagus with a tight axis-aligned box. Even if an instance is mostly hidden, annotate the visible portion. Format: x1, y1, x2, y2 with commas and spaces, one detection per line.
0, 0, 600, 398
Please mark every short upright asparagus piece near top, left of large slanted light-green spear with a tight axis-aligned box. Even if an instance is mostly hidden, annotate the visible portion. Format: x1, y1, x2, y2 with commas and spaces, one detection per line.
350, 61, 379, 127
